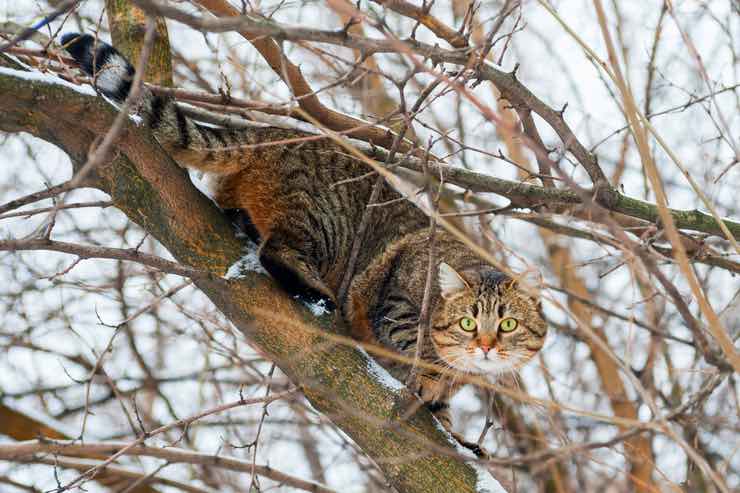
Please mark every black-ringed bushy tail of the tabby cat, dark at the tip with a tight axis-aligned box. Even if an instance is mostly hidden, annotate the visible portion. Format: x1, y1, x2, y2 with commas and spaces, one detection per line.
61, 33, 254, 173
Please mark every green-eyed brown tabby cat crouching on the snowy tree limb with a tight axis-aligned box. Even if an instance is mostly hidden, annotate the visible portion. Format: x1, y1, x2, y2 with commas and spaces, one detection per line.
62, 34, 547, 434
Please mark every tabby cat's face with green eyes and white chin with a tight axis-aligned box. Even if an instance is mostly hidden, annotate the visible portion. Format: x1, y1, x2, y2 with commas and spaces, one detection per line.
431, 262, 547, 375
